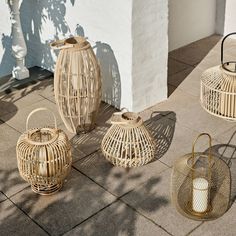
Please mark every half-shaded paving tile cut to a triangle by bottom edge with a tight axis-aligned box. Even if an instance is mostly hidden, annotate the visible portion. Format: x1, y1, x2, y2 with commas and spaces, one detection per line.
65, 201, 169, 236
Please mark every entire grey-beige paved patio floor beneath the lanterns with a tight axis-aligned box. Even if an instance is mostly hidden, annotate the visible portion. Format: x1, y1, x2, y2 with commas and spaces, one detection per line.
0, 36, 236, 236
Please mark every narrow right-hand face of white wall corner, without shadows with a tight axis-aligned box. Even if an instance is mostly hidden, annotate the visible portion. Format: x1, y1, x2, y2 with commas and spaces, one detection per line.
132, 0, 168, 111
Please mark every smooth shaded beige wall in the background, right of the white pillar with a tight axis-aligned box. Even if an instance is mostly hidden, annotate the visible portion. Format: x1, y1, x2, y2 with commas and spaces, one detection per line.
169, 0, 217, 51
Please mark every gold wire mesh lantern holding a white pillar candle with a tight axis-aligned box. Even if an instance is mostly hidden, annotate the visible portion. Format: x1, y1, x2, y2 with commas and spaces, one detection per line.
171, 133, 230, 221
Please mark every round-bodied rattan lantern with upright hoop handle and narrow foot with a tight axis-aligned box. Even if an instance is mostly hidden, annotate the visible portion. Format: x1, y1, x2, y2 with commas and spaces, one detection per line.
16, 108, 72, 195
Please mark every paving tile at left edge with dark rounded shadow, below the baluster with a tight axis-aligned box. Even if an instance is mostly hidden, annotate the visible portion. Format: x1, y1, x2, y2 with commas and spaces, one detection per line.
0, 90, 43, 118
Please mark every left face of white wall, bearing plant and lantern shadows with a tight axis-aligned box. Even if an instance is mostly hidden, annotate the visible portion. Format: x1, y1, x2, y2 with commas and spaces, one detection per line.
0, 0, 132, 109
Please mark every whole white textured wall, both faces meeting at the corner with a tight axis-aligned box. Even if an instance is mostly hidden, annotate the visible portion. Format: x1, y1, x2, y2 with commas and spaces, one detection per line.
0, 0, 168, 111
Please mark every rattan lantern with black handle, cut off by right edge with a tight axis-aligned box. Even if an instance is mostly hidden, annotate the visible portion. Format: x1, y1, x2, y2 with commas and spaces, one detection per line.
200, 33, 236, 121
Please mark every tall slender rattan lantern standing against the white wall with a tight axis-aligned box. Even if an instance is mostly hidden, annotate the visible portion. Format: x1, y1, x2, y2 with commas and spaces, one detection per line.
51, 37, 101, 134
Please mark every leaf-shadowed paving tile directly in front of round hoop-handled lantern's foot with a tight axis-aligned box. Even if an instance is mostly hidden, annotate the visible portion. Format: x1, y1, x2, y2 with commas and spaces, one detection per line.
11, 170, 116, 235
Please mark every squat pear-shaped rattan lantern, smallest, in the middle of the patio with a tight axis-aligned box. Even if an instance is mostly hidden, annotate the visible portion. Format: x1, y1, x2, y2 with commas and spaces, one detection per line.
101, 109, 155, 168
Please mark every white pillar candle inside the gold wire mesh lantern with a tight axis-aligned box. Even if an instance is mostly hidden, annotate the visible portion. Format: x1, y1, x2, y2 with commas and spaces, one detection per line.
193, 178, 209, 213
